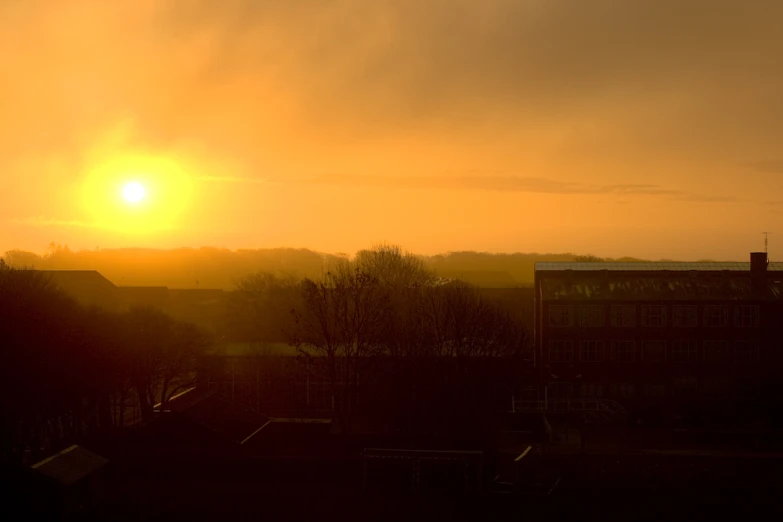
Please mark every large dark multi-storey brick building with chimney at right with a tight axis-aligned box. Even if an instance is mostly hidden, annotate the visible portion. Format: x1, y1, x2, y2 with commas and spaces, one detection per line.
534, 253, 783, 416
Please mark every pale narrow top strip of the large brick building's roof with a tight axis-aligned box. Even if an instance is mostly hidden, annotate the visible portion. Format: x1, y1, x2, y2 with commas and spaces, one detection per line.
535, 261, 783, 272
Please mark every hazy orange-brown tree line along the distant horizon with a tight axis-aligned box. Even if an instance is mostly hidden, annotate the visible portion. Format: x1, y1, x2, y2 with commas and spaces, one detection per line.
4, 243, 656, 290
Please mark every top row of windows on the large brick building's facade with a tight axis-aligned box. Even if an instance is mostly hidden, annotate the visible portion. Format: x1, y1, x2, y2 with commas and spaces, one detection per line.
548, 304, 759, 328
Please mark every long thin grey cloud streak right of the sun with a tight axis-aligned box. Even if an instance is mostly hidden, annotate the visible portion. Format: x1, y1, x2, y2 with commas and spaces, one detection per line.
303, 174, 736, 203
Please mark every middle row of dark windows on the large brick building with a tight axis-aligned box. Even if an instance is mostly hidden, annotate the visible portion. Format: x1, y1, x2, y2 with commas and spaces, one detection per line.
548, 340, 759, 363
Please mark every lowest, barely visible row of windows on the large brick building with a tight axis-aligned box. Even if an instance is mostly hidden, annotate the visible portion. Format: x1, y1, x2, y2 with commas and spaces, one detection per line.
547, 377, 760, 401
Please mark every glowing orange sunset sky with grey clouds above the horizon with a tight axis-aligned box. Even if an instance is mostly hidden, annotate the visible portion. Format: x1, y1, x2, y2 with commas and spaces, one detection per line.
0, 0, 783, 260
